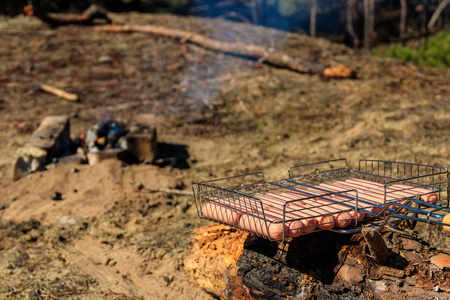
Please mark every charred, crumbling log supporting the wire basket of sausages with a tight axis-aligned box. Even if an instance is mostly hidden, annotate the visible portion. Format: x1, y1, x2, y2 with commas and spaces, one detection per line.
185, 228, 450, 300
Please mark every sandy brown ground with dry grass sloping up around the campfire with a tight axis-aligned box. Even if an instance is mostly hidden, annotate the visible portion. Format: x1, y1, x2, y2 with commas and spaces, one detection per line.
0, 13, 450, 299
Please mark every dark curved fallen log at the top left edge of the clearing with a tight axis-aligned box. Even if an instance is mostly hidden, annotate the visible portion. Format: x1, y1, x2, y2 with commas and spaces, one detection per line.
23, 4, 112, 27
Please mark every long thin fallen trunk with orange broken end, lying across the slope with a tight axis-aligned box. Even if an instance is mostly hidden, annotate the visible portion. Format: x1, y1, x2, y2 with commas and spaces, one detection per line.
95, 24, 356, 78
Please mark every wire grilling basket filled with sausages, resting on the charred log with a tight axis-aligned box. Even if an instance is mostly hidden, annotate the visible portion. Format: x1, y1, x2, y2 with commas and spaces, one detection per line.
192, 158, 450, 242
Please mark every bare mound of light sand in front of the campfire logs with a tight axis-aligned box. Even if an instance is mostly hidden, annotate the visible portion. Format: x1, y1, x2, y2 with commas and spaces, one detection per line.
3, 160, 176, 224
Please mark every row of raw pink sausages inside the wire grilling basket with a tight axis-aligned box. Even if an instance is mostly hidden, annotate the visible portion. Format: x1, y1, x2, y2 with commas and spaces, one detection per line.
202, 179, 437, 240
